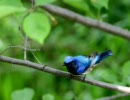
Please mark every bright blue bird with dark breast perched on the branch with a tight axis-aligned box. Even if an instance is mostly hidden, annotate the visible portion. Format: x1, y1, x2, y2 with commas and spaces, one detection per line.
64, 50, 113, 75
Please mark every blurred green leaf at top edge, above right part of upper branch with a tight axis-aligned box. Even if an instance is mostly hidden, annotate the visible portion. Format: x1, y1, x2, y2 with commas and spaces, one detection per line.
91, 0, 108, 9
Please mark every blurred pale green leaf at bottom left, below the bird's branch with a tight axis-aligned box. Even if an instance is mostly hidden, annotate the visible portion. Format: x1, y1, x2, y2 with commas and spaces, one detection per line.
11, 88, 34, 100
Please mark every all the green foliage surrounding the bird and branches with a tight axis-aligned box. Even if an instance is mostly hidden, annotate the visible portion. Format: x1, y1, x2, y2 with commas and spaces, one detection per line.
0, 0, 130, 100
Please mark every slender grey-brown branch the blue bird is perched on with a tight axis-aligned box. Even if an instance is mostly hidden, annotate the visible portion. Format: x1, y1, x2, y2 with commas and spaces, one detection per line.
0, 56, 130, 94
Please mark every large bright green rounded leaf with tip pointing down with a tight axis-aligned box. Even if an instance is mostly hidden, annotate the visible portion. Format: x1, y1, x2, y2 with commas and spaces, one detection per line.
23, 13, 51, 44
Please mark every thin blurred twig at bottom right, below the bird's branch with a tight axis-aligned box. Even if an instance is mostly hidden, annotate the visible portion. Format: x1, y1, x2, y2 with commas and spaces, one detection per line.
96, 93, 130, 100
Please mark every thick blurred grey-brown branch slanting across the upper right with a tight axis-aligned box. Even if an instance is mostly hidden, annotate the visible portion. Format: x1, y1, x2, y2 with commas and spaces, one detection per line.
41, 5, 130, 40
